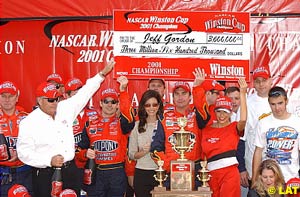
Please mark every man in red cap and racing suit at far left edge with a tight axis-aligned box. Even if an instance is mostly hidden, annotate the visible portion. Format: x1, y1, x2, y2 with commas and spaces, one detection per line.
0, 81, 32, 196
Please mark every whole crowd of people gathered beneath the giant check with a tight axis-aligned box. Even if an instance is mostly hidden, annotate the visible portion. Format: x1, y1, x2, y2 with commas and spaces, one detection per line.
0, 60, 300, 197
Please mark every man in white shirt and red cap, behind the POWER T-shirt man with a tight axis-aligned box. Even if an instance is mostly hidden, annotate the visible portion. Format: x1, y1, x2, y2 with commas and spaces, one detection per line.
244, 66, 273, 191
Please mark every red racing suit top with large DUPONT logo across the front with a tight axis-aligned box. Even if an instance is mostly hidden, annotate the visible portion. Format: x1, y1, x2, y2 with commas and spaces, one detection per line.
78, 92, 134, 165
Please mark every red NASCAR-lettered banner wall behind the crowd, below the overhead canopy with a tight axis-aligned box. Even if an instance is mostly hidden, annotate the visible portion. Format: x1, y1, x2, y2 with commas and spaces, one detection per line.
0, 18, 300, 114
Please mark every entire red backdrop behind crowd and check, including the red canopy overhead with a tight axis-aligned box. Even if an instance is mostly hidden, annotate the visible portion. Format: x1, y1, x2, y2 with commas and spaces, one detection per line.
0, 0, 300, 114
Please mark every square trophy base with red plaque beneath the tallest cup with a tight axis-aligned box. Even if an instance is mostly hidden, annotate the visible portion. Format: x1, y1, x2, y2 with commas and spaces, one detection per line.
170, 160, 195, 191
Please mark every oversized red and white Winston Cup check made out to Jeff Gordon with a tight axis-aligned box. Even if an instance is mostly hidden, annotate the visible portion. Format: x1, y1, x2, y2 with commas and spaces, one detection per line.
113, 10, 250, 81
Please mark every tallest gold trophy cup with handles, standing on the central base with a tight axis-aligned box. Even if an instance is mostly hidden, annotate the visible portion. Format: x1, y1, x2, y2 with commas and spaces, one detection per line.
171, 117, 196, 161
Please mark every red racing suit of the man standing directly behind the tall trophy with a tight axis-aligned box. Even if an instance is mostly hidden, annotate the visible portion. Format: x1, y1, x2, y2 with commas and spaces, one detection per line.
151, 86, 210, 172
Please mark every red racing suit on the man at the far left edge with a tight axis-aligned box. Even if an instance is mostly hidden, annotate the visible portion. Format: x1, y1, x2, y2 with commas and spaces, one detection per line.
0, 106, 28, 167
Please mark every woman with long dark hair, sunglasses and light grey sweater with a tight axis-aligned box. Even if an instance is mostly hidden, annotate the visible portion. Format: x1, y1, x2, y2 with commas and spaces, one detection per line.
129, 90, 163, 197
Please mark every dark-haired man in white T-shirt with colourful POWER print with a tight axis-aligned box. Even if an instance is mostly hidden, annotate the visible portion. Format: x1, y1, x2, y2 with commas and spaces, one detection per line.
252, 86, 300, 182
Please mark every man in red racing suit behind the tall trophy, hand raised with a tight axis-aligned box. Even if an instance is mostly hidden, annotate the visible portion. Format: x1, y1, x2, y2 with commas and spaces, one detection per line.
151, 68, 210, 187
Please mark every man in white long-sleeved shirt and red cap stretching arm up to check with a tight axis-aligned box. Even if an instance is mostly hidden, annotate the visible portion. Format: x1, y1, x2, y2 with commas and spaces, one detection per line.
17, 60, 115, 197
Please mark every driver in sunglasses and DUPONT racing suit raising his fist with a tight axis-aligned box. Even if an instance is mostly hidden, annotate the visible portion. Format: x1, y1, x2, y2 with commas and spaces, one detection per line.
78, 76, 134, 197
